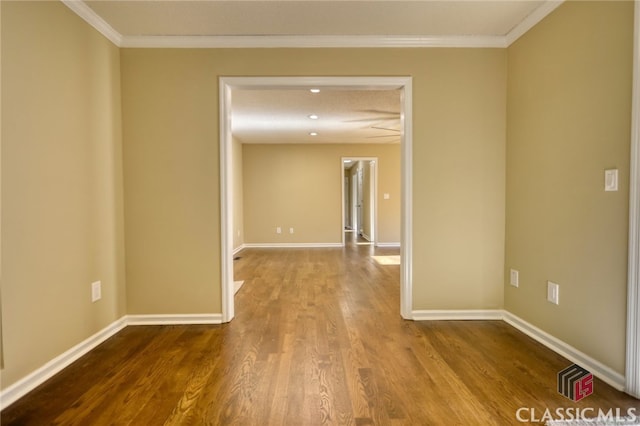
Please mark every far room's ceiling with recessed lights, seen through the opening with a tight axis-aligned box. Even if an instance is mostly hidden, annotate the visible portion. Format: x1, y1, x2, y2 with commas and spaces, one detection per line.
231, 88, 401, 144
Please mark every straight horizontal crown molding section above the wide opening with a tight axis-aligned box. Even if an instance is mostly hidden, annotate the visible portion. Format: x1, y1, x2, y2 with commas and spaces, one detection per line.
120, 35, 507, 49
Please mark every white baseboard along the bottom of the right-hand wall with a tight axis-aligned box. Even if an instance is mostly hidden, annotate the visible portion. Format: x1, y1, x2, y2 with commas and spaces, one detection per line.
504, 311, 625, 391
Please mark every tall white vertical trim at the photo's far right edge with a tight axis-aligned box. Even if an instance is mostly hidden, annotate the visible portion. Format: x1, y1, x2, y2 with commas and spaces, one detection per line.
625, 0, 640, 398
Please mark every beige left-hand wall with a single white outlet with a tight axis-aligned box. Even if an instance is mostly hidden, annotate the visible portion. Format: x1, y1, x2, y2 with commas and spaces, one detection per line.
0, 1, 125, 388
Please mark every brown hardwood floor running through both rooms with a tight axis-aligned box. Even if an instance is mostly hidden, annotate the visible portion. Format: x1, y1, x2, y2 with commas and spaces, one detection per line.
1, 245, 640, 426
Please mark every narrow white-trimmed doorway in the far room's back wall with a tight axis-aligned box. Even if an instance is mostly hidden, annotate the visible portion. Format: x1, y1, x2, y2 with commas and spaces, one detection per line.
341, 157, 378, 245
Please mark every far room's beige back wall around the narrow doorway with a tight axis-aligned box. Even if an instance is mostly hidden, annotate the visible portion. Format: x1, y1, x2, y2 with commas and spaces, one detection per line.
243, 144, 400, 243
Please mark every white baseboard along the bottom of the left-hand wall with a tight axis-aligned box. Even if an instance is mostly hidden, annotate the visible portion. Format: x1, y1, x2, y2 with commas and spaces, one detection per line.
0, 317, 127, 410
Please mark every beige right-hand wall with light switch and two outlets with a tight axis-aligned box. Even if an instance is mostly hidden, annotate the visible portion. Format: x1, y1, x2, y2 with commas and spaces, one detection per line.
504, 2, 633, 373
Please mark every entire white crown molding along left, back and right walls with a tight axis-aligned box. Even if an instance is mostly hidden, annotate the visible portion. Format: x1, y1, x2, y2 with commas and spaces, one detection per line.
60, 0, 564, 49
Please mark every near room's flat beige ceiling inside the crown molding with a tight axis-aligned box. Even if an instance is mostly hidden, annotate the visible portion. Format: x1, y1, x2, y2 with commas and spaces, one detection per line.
86, 0, 545, 36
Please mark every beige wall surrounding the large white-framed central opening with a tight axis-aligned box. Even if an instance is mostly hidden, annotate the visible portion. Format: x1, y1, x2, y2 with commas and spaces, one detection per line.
121, 49, 506, 313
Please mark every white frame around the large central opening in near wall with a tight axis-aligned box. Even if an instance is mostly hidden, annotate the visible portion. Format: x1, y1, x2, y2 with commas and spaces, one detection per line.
218, 77, 413, 322
